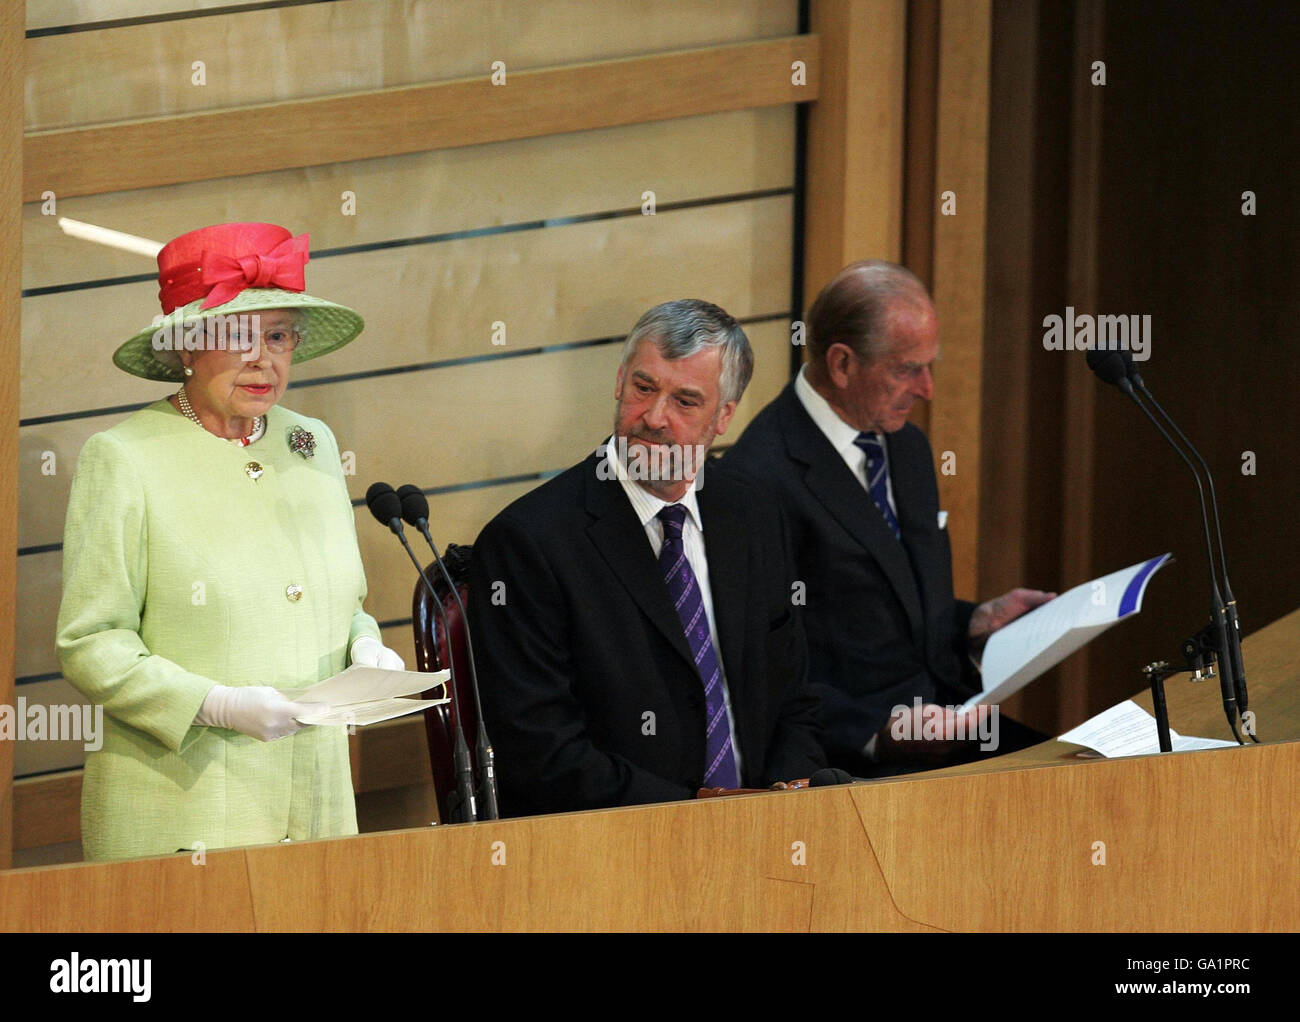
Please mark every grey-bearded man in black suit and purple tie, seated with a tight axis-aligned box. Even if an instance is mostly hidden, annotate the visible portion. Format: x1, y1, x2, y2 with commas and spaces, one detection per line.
469, 300, 824, 815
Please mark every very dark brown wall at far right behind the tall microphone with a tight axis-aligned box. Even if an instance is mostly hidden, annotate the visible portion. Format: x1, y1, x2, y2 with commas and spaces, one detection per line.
1076, 0, 1300, 717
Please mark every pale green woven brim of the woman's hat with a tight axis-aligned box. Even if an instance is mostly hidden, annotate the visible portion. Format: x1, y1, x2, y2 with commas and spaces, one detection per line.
113, 287, 365, 384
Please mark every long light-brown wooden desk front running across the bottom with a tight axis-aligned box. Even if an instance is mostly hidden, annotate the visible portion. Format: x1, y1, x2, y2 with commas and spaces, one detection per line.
0, 611, 1300, 932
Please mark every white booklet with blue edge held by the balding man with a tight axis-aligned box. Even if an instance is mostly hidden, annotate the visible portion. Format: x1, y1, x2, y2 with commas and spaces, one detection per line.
962, 554, 1170, 710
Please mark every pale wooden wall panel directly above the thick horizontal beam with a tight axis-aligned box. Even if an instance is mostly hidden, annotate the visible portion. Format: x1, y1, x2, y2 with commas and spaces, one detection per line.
26, 0, 797, 131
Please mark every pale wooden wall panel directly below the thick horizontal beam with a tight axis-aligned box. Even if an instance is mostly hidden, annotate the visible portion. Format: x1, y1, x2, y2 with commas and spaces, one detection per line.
23, 107, 794, 288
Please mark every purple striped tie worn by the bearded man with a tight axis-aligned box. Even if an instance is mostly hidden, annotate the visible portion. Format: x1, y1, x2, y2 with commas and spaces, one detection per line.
659, 504, 740, 788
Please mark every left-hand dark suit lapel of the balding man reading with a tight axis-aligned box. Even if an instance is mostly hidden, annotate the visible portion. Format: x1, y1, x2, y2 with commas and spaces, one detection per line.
780, 384, 923, 637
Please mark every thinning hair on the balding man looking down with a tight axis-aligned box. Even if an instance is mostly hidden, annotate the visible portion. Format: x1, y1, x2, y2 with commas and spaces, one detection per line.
807, 259, 931, 369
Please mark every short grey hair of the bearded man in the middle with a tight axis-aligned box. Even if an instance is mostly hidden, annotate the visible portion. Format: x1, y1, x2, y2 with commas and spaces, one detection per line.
621, 298, 754, 404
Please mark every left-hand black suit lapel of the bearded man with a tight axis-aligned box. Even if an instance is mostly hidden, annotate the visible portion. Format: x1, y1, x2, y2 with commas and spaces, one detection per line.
586, 454, 696, 670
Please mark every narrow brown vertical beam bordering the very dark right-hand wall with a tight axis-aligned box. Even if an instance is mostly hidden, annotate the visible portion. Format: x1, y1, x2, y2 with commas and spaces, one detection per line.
1060, 0, 1105, 719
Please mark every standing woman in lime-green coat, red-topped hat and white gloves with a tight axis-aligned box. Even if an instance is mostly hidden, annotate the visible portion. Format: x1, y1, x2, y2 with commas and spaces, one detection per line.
57, 224, 403, 859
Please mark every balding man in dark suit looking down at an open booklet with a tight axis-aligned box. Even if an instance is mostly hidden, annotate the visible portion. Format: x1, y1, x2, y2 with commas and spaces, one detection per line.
724, 261, 1054, 775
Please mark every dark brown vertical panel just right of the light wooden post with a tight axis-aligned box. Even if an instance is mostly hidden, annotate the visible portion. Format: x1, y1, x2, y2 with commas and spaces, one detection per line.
976, 0, 1084, 733
